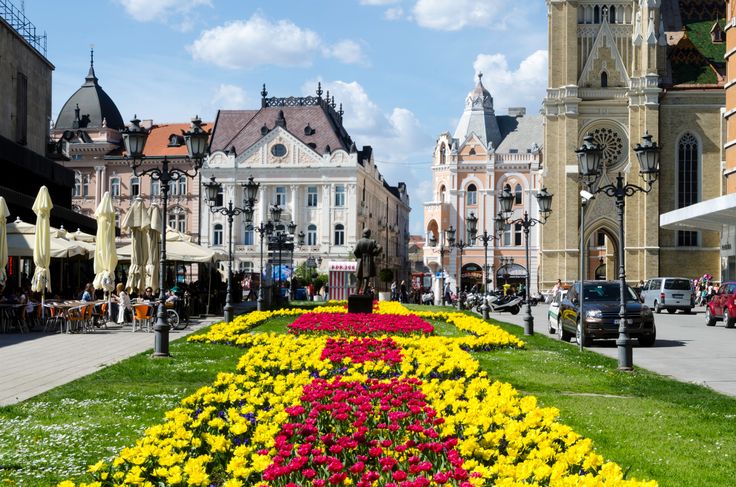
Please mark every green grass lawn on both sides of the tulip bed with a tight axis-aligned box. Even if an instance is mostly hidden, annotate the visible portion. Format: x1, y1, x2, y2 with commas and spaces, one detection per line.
0, 306, 736, 486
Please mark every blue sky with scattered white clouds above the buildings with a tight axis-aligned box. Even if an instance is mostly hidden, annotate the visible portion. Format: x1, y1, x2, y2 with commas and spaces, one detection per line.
21, 0, 547, 234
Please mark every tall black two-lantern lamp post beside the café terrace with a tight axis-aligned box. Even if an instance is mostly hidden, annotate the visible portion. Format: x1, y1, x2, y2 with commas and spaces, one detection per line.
122, 116, 210, 357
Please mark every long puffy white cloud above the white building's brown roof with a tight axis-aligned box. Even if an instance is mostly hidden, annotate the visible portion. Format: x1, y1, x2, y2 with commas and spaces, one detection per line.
188, 13, 366, 69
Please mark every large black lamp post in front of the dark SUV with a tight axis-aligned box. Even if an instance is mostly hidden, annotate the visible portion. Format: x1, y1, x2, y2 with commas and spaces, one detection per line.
575, 133, 659, 370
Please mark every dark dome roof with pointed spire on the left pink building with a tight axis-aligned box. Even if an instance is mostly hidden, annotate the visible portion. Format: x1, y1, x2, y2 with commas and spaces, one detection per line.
54, 50, 125, 130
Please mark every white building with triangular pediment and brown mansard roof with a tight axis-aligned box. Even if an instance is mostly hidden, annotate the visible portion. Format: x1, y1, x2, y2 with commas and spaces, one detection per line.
201, 87, 410, 285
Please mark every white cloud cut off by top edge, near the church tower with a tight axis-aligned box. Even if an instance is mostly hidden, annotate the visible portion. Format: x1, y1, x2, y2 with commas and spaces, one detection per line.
414, 0, 506, 31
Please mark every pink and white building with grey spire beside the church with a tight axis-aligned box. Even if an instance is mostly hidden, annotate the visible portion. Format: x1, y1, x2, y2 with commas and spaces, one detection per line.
424, 74, 543, 301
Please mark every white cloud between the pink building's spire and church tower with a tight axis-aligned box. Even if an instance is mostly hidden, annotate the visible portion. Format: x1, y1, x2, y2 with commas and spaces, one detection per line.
473, 50, 548, 113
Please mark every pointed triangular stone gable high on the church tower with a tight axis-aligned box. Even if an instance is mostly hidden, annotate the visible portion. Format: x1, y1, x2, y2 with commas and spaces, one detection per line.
578, 17, 629, 88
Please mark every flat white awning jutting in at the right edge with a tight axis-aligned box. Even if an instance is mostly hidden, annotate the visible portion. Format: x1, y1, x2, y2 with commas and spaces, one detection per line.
659, 194, 736, 232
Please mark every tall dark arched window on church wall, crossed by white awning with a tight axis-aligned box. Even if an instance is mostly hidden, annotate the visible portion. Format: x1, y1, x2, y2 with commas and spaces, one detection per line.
677, 132, 700, 247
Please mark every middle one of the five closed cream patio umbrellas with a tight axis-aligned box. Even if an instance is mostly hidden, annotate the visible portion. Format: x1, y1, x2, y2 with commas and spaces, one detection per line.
92, 191, 118, 293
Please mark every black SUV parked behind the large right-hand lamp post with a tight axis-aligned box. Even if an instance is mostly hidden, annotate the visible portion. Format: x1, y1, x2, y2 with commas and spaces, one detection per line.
559, 281, 657, 347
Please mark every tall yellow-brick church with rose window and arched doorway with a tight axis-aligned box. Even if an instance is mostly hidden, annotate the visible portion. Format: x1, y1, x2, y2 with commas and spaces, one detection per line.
541, 0, 725, 288
